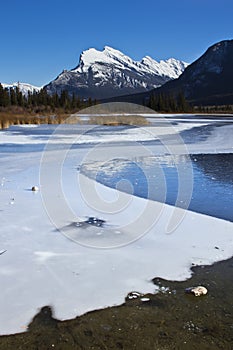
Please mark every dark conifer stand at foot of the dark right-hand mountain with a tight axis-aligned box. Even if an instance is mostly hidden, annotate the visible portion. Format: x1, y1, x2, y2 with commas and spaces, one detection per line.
148, 92, 193, 113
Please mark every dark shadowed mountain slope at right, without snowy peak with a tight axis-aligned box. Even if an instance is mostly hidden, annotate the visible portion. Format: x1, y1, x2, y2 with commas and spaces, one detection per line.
148, 40, 233, 105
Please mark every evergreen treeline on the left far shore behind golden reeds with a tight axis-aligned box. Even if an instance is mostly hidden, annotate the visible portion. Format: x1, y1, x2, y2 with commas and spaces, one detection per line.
0, 84, 97, 113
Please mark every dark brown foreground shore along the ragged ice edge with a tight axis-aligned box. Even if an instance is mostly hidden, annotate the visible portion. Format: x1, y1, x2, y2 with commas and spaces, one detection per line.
0, 258, 233, 350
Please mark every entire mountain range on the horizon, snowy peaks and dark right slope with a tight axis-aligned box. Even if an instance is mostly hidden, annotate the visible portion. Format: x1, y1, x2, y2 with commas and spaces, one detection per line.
2, 40, 233, 106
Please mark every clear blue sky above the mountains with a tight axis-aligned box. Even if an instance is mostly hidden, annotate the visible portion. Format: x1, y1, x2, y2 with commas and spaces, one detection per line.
0, 0, 233, 86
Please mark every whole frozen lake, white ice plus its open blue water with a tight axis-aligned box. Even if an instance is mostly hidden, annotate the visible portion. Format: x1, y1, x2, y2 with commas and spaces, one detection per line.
0, 115, 233, 334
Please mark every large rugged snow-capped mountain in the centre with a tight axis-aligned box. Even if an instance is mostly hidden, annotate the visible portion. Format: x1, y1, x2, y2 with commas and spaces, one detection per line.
46, 46, 188, 99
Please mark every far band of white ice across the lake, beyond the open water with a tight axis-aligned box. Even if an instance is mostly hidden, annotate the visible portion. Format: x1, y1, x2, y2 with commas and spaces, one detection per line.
0, 114, 233, 154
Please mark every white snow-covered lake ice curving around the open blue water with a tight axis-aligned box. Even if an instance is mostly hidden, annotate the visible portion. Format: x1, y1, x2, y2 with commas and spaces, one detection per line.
0, 120, 233, 334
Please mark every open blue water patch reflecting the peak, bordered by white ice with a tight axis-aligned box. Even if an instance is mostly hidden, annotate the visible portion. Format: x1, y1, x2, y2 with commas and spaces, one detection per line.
87, 153, 233, 221
